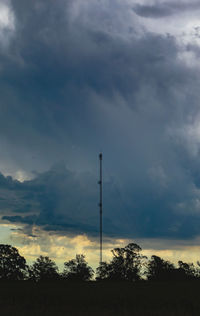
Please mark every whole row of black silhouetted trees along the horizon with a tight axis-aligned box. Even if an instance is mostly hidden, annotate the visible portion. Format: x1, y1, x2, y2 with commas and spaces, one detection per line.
0, 243, 200, 282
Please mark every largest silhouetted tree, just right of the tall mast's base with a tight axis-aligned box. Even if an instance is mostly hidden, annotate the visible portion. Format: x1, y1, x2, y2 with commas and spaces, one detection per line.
97, 243, 146, 281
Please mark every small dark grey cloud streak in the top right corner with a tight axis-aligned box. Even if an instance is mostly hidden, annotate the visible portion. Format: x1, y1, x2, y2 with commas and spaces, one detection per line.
133, 1, 200, 19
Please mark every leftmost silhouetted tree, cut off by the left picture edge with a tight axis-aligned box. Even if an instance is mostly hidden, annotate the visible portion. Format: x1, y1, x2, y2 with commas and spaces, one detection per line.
0, 244, 28, 280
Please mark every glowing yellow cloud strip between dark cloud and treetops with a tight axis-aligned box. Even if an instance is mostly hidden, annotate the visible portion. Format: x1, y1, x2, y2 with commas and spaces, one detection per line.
0, 224, 200, 270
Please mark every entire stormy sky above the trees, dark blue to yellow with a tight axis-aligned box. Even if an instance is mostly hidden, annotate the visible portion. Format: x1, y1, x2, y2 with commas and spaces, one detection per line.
0, 0, 200, 266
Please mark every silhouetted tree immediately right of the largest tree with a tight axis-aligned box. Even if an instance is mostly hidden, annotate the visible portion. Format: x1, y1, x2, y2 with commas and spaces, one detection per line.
146, 256, 175, 281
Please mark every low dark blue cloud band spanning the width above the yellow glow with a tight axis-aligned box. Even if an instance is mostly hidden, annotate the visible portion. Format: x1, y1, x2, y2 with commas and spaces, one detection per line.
0, 165, 200, 239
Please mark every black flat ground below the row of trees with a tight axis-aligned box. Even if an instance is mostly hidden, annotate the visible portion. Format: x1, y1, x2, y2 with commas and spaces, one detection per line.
0, 281, 200, 316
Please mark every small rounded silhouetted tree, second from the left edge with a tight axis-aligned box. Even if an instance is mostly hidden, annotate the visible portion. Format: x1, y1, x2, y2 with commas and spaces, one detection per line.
30, 256, 59, 281
